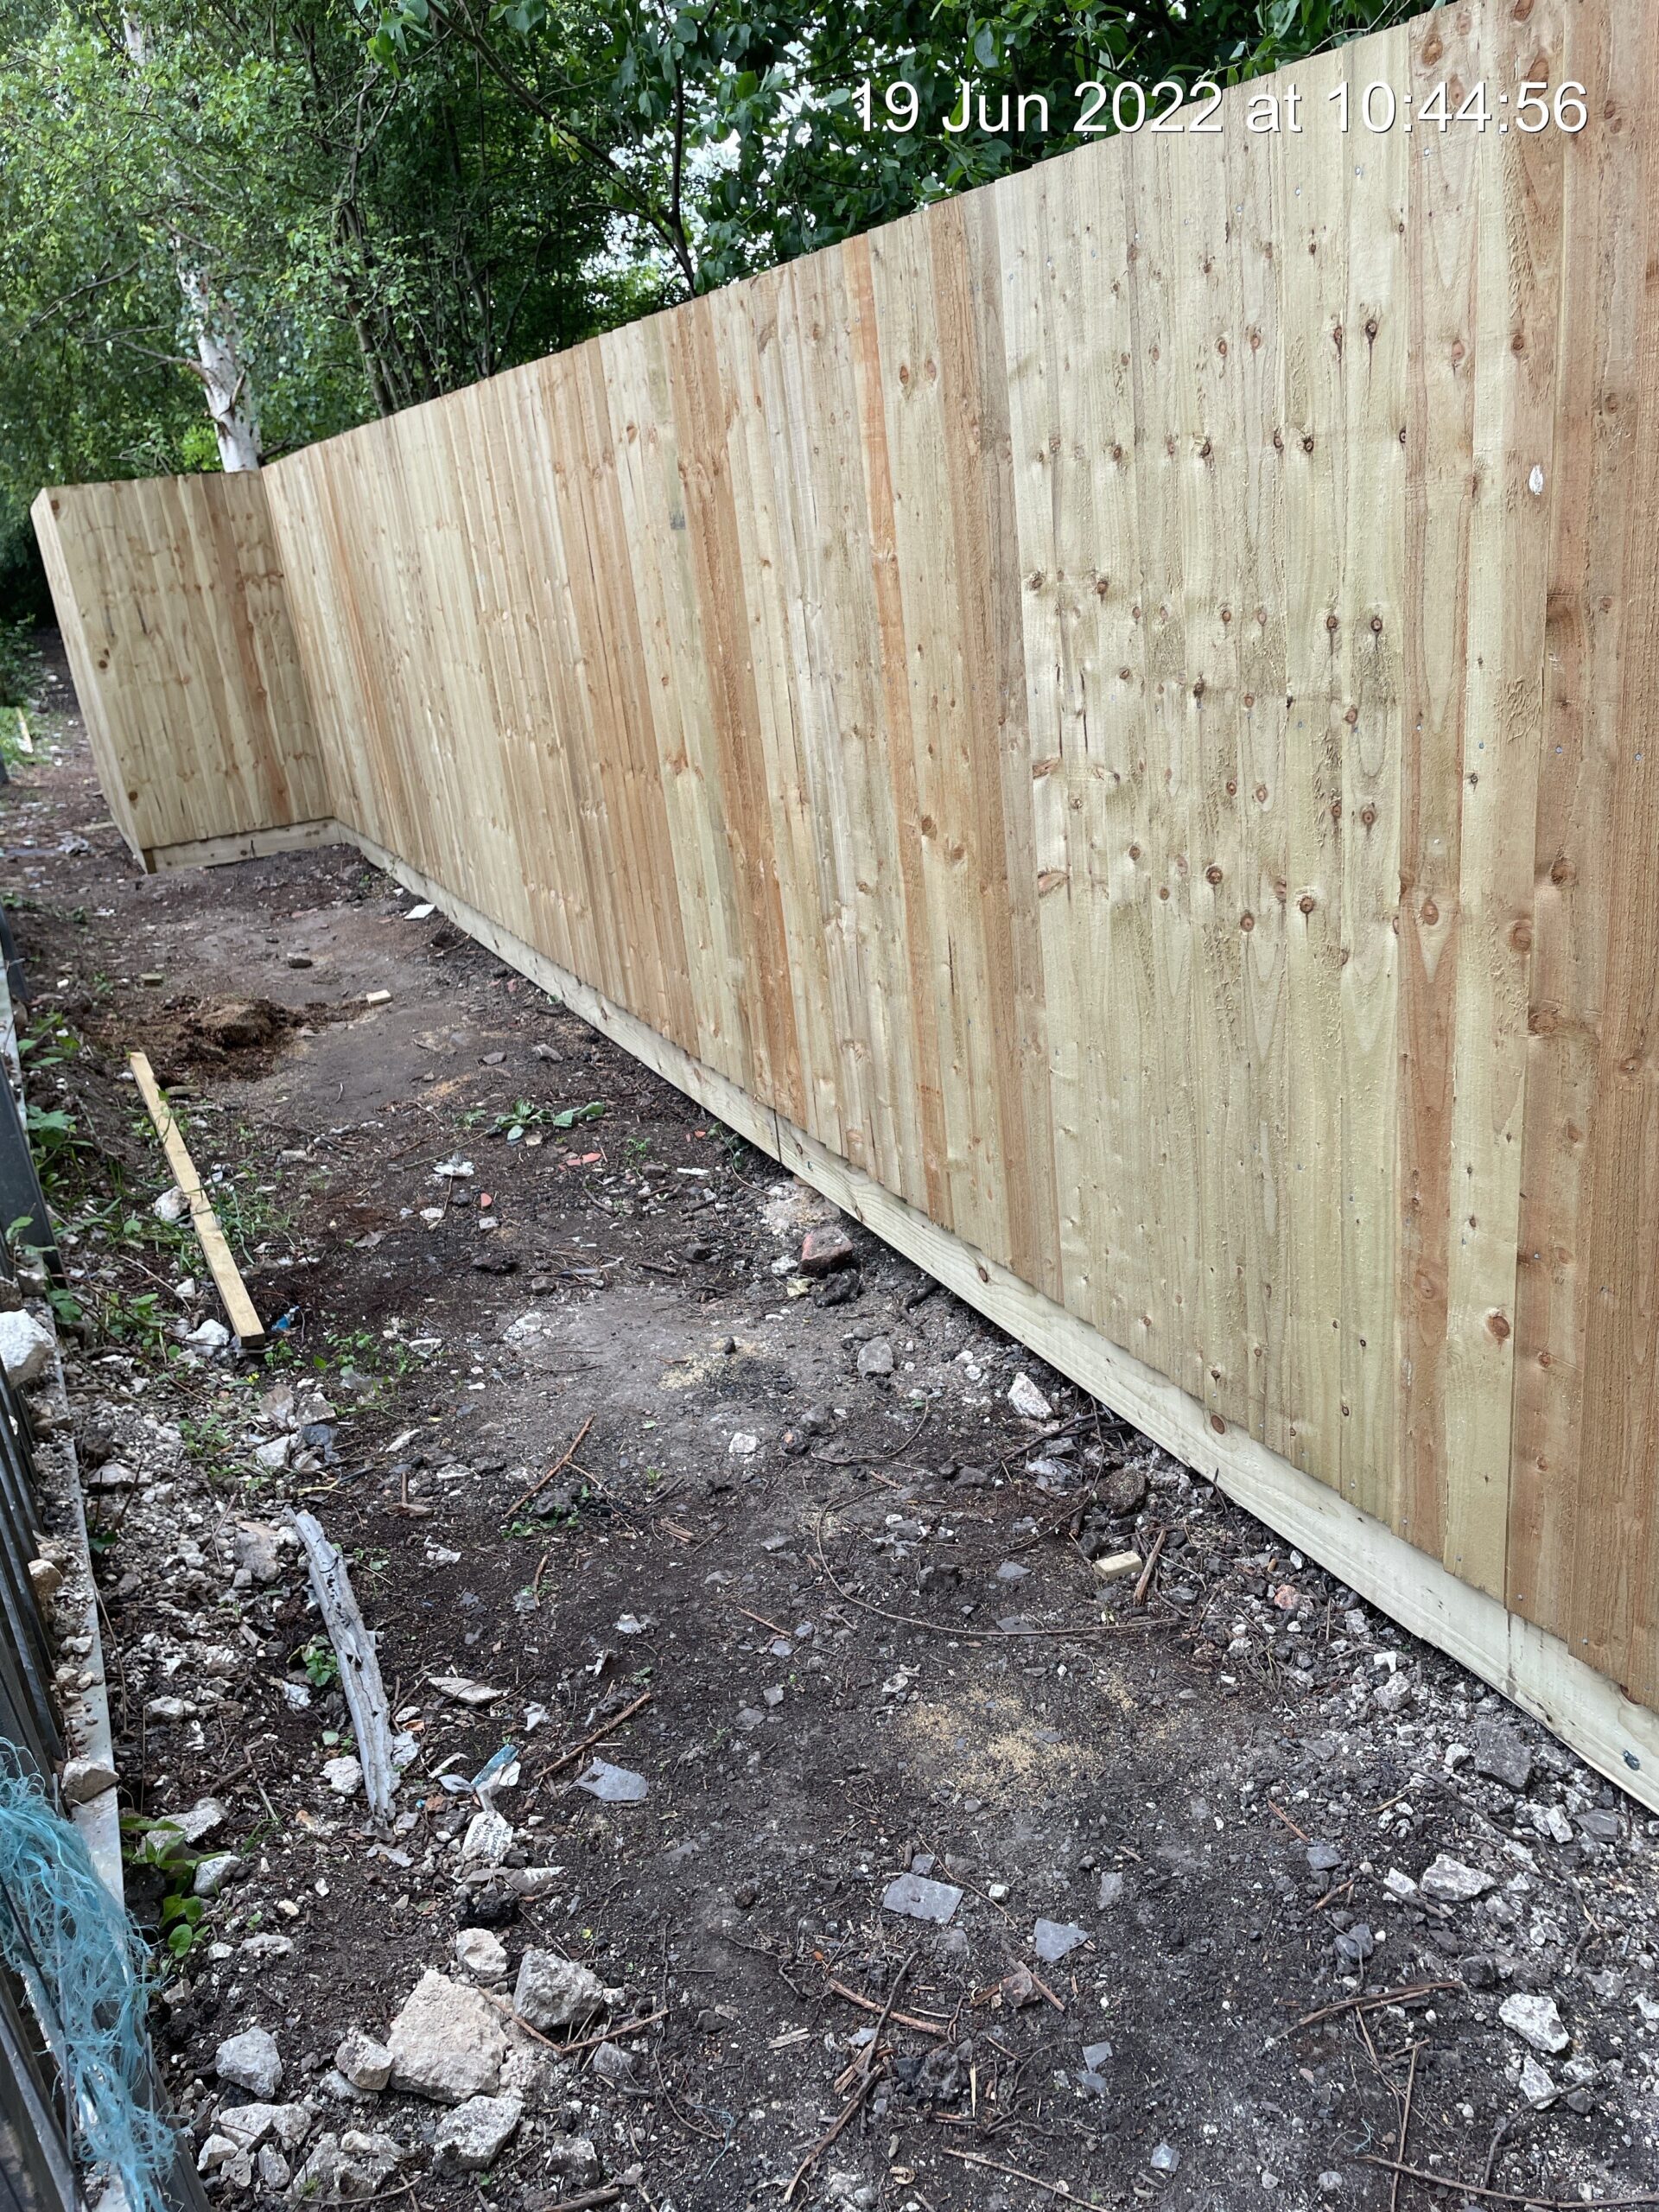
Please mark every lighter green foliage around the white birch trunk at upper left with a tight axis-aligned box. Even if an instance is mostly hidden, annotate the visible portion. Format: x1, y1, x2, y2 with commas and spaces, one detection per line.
0, 0, 635, 504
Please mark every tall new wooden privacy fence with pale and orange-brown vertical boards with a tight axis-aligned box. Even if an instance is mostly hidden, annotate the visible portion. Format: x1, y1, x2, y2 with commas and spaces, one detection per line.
35, 0, 1659, 1802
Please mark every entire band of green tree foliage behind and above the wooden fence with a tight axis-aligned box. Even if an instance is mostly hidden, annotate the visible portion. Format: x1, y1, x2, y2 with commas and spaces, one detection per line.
0, 0, 1418, 526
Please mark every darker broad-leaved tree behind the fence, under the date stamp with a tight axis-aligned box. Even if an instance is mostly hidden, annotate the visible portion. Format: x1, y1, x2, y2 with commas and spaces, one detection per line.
356, 0, 1421, 296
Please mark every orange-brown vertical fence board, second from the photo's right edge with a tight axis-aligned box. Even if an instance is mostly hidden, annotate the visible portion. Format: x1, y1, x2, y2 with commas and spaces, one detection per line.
1509, 9, 1650, 1635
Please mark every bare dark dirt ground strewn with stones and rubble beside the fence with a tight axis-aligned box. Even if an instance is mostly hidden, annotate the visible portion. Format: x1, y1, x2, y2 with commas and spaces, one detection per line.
0, 628, 1659, 2212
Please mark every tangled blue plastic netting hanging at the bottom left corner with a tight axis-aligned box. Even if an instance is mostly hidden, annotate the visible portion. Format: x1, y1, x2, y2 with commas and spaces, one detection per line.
0, 1745, 175, 2212
